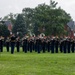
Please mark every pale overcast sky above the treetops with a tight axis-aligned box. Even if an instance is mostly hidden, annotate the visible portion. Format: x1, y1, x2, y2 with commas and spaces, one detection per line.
0, 0, 75, 21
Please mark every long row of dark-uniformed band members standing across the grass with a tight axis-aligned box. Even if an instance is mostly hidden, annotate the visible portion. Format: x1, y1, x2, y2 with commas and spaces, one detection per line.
0, 34, 75, 54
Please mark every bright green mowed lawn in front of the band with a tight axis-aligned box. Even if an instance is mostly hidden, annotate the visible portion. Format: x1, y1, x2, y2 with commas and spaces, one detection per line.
0, 47, 75, 75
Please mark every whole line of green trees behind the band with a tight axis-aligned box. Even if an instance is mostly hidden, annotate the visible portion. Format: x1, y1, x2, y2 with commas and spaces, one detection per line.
0, 0, 72, 36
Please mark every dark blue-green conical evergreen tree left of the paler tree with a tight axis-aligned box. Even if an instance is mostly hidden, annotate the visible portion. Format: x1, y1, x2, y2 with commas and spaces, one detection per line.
13, 14, 27, 36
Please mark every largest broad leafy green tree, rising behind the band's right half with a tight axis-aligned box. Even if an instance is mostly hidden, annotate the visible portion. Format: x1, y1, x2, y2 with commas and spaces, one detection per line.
33, 0, 71, 35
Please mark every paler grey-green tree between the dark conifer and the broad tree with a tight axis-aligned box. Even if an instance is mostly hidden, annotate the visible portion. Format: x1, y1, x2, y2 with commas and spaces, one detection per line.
22, 8, 34, 33
